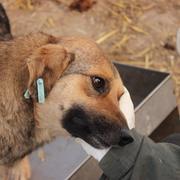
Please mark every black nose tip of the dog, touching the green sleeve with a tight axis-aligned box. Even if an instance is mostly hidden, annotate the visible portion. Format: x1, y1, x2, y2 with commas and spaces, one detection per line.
118, 129, 134, 146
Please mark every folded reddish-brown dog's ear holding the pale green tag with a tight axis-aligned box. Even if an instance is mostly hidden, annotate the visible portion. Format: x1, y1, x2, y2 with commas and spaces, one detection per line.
27, 44, 74, 97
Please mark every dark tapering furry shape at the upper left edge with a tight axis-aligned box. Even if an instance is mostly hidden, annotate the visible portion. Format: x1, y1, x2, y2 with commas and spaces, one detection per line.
0, 3, 12, 41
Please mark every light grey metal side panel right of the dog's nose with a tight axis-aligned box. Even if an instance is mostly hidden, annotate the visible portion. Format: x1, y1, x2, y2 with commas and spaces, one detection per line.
135, 76, 177, 136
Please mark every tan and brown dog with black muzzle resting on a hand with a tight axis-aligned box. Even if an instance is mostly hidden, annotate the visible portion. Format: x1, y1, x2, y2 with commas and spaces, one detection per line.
0, 33, 131, 179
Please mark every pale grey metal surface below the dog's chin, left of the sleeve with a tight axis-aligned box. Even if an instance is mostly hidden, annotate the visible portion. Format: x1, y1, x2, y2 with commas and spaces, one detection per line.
30, 138, 88, 180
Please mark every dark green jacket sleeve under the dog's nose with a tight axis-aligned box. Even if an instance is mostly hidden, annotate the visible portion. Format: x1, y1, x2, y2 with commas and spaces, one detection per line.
99, 130, 180, 180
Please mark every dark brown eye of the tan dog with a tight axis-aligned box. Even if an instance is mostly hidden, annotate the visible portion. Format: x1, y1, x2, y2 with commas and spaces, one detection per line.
91, 76, 106, 93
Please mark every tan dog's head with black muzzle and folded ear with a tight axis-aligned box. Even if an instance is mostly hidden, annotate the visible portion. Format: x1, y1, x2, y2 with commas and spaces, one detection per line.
28, 37, 132, 148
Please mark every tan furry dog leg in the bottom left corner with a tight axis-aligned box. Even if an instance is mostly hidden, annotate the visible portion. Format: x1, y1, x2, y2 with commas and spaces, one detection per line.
0, 156, 31, 180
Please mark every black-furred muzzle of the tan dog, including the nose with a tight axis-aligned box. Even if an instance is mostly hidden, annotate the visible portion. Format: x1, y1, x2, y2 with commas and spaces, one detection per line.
62, 106, 133, 148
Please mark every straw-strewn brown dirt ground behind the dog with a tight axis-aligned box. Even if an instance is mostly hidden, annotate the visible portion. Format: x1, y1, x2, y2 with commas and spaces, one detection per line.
0, 0, 180, 111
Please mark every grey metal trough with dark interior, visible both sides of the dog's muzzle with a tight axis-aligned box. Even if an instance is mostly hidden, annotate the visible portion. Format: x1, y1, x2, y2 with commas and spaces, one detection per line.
30, 63, 176, 180
